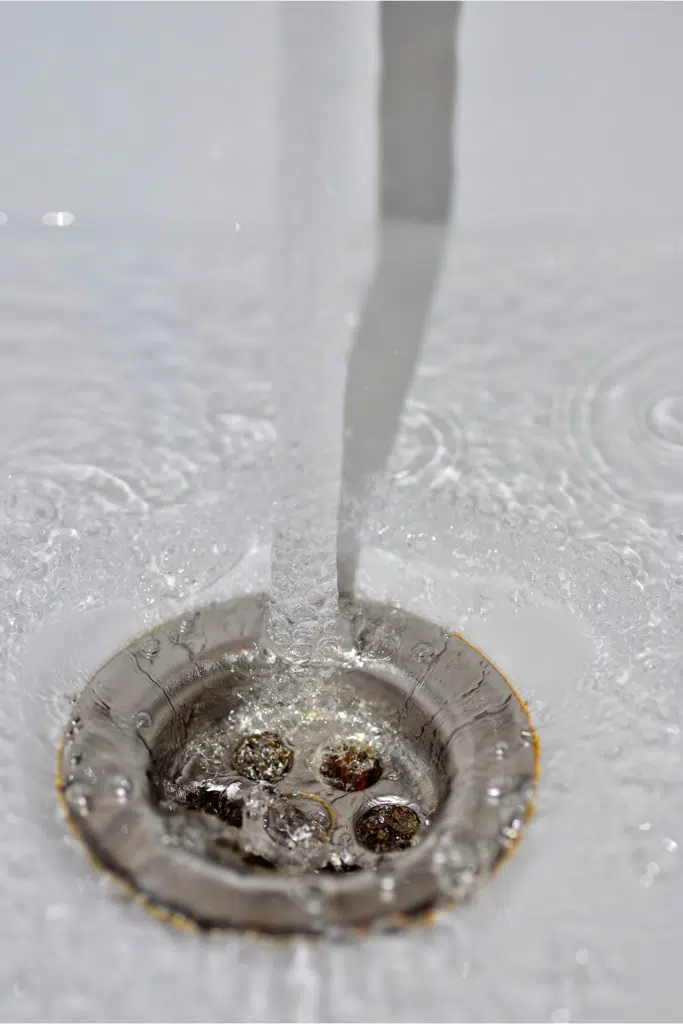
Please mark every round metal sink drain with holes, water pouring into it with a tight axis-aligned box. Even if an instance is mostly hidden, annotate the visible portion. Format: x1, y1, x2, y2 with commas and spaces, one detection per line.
59, 596, 537, 932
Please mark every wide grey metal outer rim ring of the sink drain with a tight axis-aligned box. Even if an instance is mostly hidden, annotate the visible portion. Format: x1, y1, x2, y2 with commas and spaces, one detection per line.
58, 595, 538, 933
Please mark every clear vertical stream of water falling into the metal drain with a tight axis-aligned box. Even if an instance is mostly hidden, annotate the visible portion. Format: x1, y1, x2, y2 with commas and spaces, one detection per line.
268, 4, 352, 660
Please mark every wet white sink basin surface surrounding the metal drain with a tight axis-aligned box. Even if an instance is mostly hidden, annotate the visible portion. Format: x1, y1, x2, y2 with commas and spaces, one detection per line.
0, 4, 683, 1021
